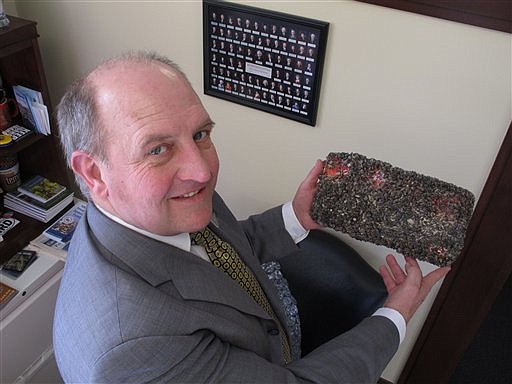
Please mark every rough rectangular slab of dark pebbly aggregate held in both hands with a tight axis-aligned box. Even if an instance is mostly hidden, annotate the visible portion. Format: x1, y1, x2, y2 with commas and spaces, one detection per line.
311, 152, 475, 266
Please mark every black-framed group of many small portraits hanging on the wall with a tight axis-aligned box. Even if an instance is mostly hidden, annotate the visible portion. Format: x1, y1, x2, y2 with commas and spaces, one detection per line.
203, 0, 329, 126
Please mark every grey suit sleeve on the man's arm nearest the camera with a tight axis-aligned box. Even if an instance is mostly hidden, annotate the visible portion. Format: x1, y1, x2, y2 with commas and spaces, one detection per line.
90, 316, 398, 384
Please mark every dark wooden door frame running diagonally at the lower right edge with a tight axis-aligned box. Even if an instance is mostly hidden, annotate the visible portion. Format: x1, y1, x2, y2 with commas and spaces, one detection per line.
398, 123, 512, 384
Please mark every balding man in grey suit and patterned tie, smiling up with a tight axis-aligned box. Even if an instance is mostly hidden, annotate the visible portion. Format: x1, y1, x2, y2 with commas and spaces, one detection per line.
54, 53, 448, 383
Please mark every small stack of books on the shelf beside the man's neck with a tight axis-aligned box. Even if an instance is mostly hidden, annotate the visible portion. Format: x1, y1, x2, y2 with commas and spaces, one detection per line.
4, 175, 73, 223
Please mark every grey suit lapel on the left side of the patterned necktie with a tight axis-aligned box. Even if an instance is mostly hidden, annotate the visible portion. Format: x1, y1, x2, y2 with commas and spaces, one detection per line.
87, 204, 269, 319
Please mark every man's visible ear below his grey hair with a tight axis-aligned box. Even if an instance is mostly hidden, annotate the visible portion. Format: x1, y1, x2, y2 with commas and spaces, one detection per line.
71, 151, 108, 198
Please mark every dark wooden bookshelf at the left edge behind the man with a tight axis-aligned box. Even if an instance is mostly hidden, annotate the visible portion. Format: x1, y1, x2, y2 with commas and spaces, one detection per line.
0, 16, 75, 264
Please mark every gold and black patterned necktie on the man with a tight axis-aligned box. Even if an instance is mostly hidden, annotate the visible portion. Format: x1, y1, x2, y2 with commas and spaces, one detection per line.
190, 227, 291, 364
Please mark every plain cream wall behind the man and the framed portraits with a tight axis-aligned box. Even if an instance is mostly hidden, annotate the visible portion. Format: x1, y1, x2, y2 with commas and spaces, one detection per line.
9, 0, 512, 381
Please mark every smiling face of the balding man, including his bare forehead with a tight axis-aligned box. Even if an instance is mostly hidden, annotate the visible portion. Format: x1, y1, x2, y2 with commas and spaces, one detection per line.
93, 64, 219, 235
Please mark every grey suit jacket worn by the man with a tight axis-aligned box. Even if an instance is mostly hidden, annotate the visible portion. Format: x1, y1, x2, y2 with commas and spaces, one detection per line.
54, 195, 398, 383
